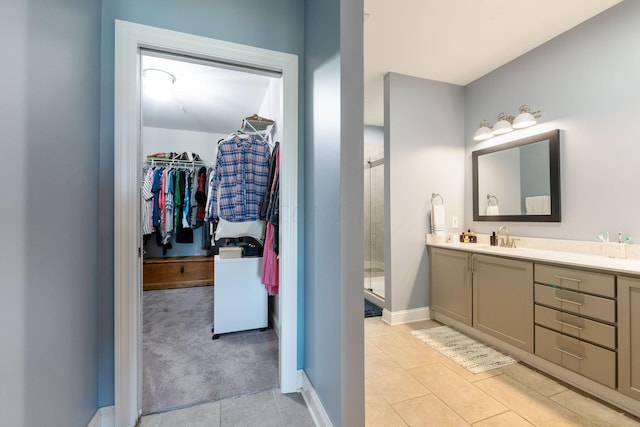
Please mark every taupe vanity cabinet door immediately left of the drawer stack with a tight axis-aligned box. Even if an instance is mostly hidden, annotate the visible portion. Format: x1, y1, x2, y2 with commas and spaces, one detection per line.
473, 255, 533, 352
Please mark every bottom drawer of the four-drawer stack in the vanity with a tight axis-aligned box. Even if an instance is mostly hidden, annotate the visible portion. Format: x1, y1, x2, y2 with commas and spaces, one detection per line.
535, 326, 616, 388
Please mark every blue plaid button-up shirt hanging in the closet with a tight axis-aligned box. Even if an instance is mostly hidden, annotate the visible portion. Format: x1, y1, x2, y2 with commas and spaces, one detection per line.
211, 136, 269, 222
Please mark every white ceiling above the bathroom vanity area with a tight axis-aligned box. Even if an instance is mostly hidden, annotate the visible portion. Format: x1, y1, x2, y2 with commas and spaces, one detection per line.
364, 0, 621, 126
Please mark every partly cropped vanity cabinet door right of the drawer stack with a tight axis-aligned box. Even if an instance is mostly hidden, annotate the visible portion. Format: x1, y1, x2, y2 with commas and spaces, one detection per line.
618, 277, 640, 400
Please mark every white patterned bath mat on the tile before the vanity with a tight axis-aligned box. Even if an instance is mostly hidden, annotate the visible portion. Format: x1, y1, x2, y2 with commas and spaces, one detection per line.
411, 326, 516, 374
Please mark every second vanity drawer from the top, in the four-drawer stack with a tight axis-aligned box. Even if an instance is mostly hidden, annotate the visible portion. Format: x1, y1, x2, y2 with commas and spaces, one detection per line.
535, 283, 616, 323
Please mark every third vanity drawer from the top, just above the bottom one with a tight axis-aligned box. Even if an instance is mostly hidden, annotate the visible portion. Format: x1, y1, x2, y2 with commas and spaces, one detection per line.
535, 305, 616, 349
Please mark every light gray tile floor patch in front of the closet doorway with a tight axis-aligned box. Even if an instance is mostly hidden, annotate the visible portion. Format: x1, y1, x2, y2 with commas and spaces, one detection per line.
140, 389, 314, 427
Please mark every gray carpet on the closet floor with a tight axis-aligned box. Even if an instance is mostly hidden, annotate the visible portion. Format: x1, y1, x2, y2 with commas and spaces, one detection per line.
142, 286, 279, 414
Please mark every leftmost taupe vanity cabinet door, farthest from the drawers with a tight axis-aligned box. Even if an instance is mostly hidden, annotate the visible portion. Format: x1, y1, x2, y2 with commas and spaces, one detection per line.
429, 248, 471, 325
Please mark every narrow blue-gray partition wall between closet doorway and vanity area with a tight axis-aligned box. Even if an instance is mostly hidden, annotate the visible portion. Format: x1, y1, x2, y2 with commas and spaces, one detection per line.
304, 0, 364, 426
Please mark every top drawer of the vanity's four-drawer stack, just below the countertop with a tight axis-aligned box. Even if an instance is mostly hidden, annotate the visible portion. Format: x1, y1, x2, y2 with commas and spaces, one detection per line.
534, 264, 616, 298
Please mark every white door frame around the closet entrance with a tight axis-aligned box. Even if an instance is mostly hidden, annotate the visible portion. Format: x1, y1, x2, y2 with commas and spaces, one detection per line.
113, 20, 300, 426
